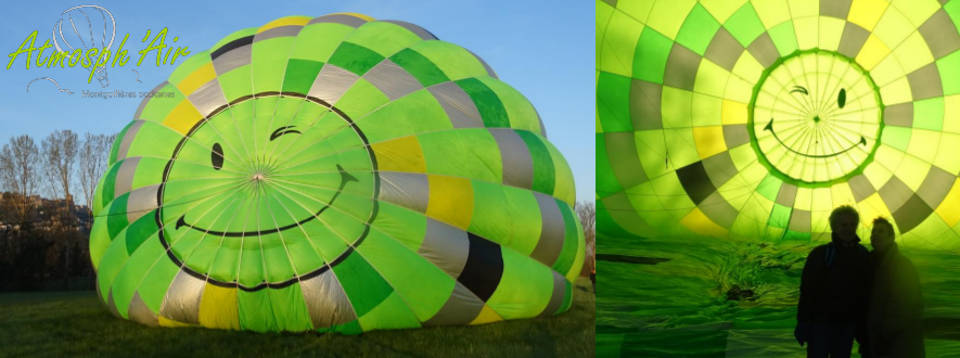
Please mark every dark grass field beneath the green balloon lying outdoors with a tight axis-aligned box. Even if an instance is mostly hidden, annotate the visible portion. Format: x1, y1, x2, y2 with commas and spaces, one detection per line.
0, 277, 594, 358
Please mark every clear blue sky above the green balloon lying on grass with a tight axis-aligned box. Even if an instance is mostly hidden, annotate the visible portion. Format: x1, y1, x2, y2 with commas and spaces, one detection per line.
0, 0, 595, 200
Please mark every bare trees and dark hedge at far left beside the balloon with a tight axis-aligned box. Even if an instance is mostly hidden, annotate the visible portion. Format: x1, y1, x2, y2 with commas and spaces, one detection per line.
0, 130, 115, 291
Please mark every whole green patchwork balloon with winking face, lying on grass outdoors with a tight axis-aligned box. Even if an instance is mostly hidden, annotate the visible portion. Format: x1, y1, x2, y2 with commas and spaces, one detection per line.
90, 14, 584, 333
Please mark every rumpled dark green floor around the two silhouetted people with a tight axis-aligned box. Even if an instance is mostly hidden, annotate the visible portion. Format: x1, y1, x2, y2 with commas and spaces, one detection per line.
597, 239, 960, 357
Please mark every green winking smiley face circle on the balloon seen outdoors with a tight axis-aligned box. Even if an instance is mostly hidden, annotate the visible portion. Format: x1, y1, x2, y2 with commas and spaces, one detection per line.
155, 94, 378, 289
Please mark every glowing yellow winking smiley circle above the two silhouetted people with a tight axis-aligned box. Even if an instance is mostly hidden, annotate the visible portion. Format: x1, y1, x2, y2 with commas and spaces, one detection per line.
747, 50, 883, 185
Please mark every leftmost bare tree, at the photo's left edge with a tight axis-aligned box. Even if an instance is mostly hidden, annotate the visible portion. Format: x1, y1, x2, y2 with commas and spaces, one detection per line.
0, 135, 40, 223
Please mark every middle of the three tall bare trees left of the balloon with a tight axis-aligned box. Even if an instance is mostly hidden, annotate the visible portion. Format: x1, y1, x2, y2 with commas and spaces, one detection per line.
41, 129, 77, 205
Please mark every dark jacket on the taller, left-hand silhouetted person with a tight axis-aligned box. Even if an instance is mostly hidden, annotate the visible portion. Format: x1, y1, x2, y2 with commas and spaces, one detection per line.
797, 236, 870, 324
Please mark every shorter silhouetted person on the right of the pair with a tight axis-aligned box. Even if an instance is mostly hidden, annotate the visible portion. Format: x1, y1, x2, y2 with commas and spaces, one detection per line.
867, 218, 924, 358
